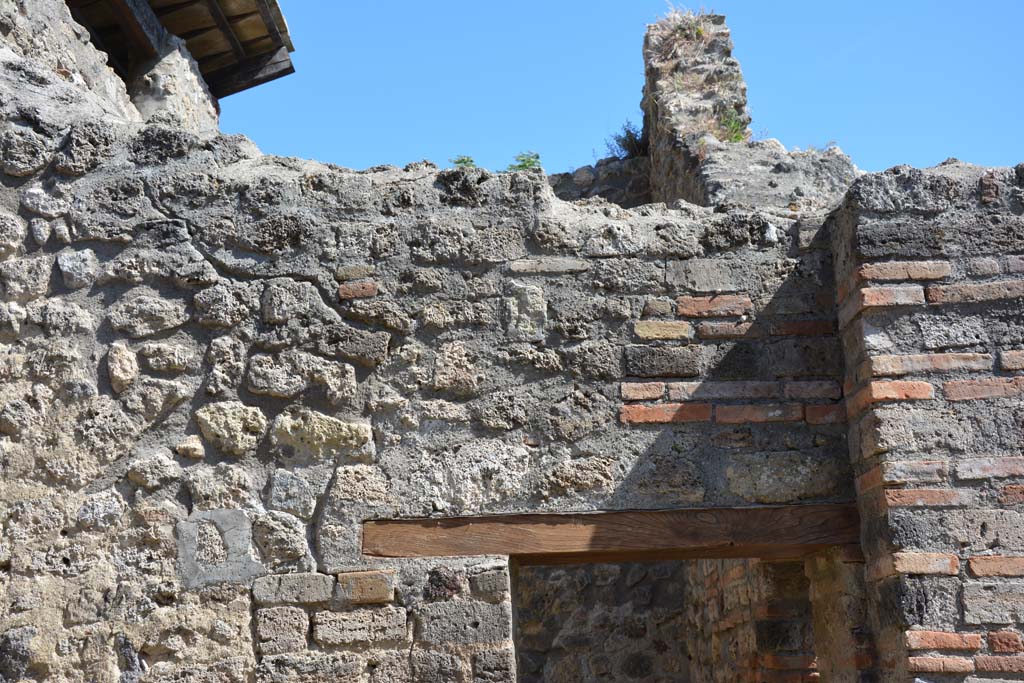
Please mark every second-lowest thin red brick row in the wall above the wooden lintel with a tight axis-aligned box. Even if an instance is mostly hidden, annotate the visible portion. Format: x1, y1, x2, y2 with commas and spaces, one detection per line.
621, 380, 843, 401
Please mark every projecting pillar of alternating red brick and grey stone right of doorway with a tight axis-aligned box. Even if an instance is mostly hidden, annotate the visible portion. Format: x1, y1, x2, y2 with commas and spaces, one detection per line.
831, 163, 1024, 681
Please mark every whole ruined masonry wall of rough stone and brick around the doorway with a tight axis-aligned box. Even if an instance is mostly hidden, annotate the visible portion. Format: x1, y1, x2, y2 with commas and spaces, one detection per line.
0, 0, 1024, 683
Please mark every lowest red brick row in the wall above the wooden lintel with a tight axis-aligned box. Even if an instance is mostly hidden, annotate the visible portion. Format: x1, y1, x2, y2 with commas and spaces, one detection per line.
620, 402, 846, 425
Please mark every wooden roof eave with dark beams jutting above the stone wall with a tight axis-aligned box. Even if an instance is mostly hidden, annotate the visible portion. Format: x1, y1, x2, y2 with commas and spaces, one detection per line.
67, 0, 295, 97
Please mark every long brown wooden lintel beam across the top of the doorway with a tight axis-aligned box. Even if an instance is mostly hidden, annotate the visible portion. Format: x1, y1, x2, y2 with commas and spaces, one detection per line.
362, 504, 860, 564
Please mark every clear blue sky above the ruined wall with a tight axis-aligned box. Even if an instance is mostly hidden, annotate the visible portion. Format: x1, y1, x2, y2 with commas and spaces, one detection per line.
222, 0, 1024, 173
